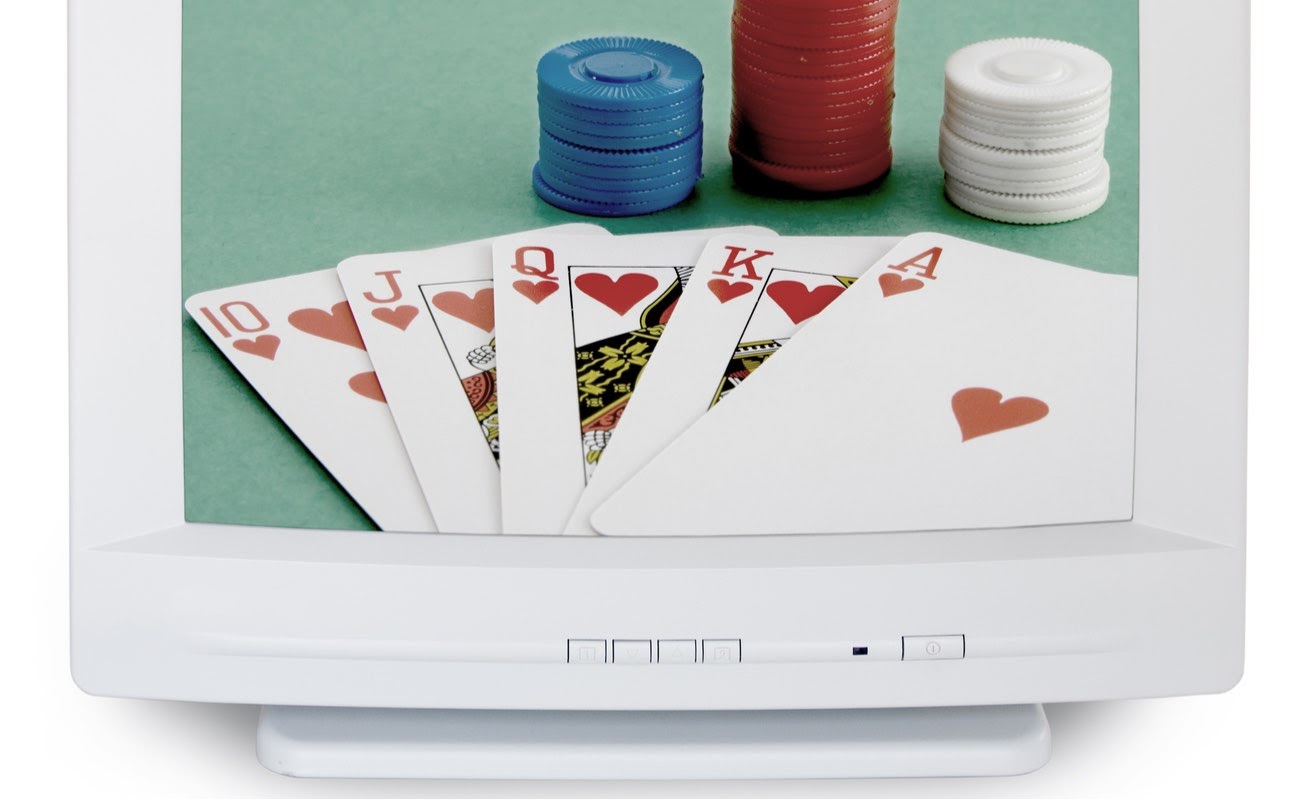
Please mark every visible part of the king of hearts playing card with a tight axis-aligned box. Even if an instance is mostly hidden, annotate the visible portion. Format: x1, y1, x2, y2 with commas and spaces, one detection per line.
564, 234, 898, 535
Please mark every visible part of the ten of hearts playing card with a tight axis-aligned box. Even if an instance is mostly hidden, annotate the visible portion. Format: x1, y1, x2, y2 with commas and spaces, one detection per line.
185, 269, 437, 532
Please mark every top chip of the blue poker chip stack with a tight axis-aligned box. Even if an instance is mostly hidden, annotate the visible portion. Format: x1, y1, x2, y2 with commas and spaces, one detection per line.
537, 36, 705, 112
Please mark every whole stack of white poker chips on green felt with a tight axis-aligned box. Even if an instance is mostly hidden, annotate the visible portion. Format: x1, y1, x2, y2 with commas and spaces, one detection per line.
939, 39, 1112, 225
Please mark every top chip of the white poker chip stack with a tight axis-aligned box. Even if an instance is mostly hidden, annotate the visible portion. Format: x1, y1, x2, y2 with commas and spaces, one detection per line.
944, 39, 1110, 109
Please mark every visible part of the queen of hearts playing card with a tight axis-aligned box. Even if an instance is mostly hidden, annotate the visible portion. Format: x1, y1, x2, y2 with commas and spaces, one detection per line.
493, 229, 771, 533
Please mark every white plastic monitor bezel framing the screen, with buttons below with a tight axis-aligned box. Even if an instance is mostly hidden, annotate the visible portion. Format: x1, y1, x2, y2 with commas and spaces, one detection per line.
70, 0, 1249, 708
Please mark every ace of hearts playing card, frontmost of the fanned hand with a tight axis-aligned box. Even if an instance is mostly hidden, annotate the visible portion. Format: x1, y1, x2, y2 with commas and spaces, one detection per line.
592, 233, 1138, 535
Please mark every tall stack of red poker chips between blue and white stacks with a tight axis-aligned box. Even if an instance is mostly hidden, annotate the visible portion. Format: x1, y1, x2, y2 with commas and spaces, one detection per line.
731, 0, 898, 194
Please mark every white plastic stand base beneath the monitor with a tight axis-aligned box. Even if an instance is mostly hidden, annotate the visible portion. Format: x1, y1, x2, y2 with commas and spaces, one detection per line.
257, 705, 1050, 779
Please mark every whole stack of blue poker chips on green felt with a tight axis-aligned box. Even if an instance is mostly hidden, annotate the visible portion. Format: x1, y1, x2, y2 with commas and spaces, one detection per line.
533, 36, 705, 217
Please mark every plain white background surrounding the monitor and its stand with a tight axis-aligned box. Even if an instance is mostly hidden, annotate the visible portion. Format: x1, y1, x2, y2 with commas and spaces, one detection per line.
0, 0, 1300, 799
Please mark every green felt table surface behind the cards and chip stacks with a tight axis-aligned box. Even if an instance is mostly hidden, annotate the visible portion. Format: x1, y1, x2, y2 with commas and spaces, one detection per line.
177, 0, 1139, 529
